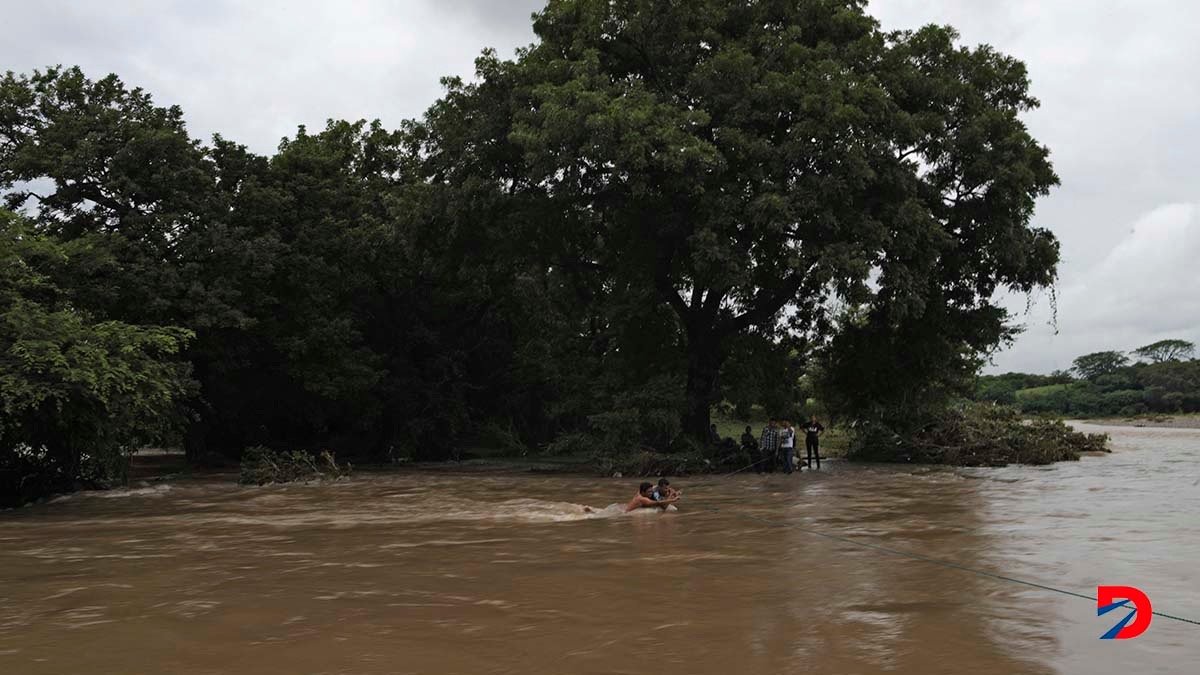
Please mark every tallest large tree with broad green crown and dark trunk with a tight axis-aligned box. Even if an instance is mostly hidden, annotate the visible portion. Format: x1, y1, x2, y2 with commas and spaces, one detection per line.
421, 0, 1057, 437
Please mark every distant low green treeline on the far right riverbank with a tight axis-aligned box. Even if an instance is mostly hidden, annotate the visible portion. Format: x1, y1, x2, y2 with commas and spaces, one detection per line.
976, 340, 1200, 417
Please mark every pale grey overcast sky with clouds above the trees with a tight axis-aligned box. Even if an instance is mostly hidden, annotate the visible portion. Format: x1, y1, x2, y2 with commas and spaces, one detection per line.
0, 0, 1200, 372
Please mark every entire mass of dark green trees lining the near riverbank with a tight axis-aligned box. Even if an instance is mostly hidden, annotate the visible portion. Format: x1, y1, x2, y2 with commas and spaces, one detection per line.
0, 0, 1058, 503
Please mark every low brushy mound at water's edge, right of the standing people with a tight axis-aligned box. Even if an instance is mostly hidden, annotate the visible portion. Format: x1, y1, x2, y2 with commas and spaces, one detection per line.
851, 404, 1108, 466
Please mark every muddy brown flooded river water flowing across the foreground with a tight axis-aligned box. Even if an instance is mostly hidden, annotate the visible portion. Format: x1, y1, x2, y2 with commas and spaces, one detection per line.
0, 428, 1200, 675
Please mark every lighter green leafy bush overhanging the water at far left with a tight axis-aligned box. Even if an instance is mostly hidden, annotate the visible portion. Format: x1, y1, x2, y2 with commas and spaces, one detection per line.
0, 210, 191, 506
